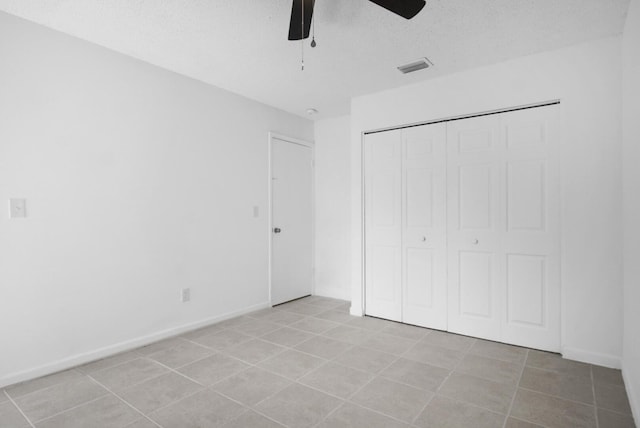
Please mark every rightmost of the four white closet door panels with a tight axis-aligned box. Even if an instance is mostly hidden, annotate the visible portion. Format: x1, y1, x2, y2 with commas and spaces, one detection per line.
500, 106, 560, 351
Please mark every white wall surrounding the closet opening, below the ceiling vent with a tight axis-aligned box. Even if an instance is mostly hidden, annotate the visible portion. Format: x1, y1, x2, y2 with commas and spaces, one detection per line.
351, 37, 622, 367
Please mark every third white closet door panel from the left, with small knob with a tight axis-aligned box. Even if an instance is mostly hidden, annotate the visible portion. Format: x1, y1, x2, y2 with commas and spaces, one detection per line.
447, 115, 504, 340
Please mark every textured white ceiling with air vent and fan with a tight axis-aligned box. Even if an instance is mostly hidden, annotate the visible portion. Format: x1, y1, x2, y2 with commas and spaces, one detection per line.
0, 0, 629, 117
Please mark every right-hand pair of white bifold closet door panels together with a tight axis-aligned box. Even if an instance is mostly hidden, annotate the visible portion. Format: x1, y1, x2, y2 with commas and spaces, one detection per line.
447, 106, 560, 351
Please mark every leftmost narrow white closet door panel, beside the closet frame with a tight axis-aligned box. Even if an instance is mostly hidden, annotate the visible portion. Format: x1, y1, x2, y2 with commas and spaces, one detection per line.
364, 130, 402, 321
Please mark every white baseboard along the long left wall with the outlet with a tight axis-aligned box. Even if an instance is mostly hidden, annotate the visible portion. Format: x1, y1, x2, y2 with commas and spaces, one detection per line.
0, 302, 271, 388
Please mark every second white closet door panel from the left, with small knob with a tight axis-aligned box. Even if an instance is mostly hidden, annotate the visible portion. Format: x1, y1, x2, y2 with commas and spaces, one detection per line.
402, 123, 447, 330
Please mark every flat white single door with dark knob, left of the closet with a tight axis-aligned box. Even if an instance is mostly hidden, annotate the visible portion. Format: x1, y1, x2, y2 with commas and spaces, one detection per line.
271, 137, 313, 305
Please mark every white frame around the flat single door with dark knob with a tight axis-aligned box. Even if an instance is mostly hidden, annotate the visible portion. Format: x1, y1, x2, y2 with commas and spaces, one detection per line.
267, 131, 316, 306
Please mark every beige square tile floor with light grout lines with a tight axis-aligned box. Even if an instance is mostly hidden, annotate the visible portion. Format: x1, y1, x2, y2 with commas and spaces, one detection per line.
0, 297, 634, 428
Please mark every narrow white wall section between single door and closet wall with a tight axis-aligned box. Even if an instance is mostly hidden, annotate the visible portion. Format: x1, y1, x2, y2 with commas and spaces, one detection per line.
315, 116, 351, 300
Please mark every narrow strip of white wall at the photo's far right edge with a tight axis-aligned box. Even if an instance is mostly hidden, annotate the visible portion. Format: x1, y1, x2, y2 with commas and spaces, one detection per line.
622, 0, 640, 423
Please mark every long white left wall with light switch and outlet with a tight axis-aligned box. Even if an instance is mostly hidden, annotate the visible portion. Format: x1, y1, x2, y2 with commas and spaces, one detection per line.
0, 13, 313, 386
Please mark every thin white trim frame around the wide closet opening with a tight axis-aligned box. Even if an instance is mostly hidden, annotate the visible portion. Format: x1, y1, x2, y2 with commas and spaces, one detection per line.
360, 99, 566, 334
